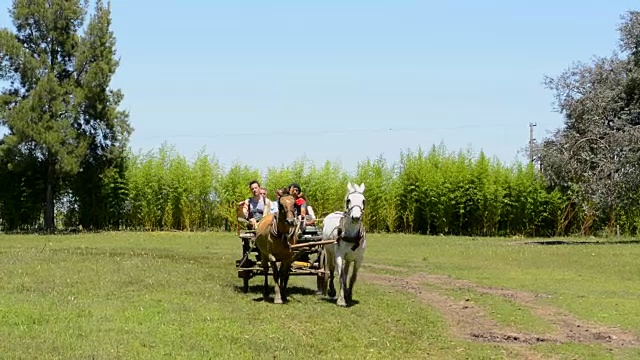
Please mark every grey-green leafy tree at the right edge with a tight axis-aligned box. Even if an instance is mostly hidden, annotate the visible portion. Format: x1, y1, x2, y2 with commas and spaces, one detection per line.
537, 11, 640, 231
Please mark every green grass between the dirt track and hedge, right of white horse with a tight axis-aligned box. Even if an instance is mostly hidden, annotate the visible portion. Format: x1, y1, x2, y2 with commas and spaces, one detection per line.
367, 235, 640, 334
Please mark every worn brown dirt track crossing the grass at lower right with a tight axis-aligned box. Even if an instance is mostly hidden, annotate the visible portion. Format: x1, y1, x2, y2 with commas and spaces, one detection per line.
361, 273, 640, 352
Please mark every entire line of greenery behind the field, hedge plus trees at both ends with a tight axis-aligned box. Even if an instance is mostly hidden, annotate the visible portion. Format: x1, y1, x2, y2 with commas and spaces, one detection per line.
0, 0, 640, 236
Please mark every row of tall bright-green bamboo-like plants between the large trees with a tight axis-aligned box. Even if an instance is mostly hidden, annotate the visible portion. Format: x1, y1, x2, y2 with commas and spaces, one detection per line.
0, 145, 640, 236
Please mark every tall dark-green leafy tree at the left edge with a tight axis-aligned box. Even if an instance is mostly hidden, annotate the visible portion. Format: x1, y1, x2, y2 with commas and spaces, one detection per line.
0, 0, 132, 230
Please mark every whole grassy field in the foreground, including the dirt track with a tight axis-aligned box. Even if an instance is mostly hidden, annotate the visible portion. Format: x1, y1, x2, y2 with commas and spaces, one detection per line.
0, 233, 640, 359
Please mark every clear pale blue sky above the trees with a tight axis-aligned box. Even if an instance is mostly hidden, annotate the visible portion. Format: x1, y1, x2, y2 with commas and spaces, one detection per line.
0, 0, 637, 176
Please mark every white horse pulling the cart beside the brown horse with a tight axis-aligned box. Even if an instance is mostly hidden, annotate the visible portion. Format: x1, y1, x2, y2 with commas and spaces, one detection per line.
322, 182, 367, 306
